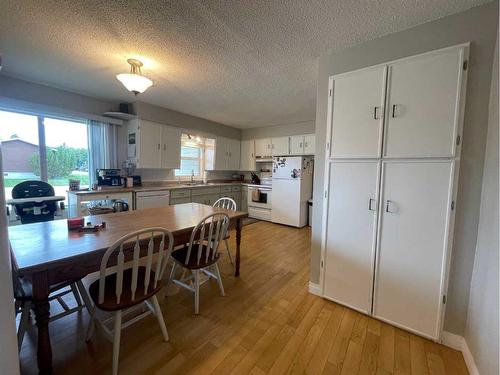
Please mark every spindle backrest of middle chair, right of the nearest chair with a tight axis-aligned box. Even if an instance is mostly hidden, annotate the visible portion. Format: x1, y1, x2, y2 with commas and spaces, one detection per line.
184, 212, 229, 265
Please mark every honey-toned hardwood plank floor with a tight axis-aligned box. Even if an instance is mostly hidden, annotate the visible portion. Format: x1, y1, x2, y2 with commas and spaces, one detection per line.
17, 222, 468, 375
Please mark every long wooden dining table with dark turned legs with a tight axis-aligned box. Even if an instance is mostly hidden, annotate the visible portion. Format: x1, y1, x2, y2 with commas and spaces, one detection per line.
9, 203, 248, 374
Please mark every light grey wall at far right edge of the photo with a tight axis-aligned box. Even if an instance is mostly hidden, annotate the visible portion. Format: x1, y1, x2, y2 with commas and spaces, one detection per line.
465, 33, 500, 375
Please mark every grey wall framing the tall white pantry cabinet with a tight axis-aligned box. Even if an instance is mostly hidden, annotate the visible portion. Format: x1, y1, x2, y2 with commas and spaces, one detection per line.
311, 2, 498, 334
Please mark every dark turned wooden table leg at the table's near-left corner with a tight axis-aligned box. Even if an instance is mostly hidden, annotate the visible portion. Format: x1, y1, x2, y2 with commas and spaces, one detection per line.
32, 272, 52, 375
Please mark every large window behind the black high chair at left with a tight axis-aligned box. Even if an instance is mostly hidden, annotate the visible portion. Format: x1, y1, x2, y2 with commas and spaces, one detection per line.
0, 111, 89, 199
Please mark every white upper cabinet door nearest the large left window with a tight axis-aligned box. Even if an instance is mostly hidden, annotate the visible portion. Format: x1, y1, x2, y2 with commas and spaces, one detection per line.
138, 120, 163, 168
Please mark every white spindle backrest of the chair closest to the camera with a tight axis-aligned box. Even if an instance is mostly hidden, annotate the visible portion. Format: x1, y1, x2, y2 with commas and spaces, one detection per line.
99, 227, 174, 303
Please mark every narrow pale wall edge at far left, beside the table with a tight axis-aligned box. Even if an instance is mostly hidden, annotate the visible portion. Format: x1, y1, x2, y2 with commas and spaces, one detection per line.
0, 146, 19, 375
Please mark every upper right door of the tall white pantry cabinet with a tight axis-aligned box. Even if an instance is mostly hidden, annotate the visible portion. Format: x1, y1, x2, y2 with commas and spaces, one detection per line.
384, 49, 463, 157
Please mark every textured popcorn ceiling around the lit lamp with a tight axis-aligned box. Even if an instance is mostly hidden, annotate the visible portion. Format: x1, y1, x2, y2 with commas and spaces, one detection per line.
0, 0, 487, 128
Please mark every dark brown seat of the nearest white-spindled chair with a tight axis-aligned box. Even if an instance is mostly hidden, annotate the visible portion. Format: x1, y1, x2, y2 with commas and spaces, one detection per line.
89, 267, 162, 311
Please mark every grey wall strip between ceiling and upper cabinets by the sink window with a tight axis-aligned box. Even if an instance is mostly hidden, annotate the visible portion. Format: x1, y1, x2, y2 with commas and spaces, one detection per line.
135, 102, 241, 139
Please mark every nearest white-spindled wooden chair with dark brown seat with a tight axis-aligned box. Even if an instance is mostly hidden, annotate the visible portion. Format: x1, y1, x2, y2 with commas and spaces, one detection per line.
86, 228, 174, 374
